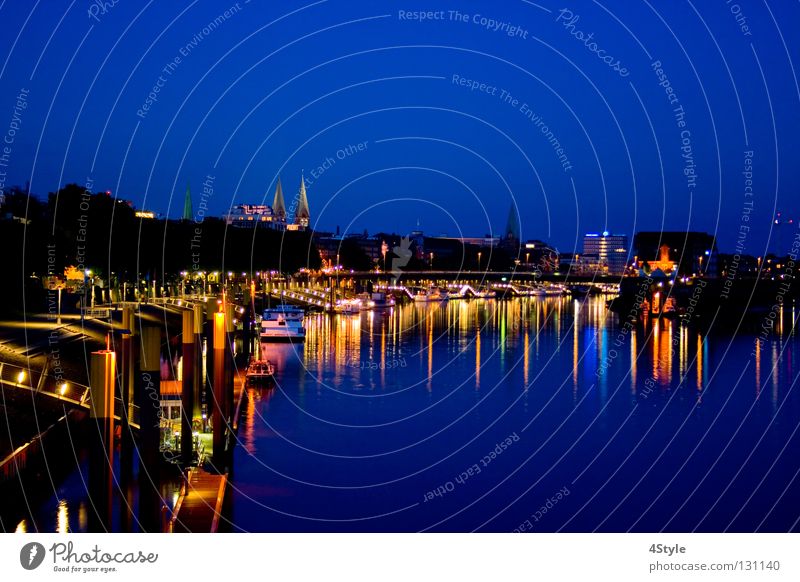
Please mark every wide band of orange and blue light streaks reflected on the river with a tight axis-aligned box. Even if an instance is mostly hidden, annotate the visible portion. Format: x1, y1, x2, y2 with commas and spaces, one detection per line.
290, 298, 720, 400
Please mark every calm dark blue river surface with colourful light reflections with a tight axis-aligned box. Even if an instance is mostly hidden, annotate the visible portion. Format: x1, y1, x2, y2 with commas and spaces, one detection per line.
229, 298, 800, 531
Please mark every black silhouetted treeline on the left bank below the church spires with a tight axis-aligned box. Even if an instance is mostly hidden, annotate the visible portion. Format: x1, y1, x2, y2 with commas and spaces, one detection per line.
0, 184, 320, 281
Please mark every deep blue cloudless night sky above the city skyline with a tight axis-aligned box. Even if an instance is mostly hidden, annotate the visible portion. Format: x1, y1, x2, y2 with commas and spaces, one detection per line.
0, 0, 800, 255
